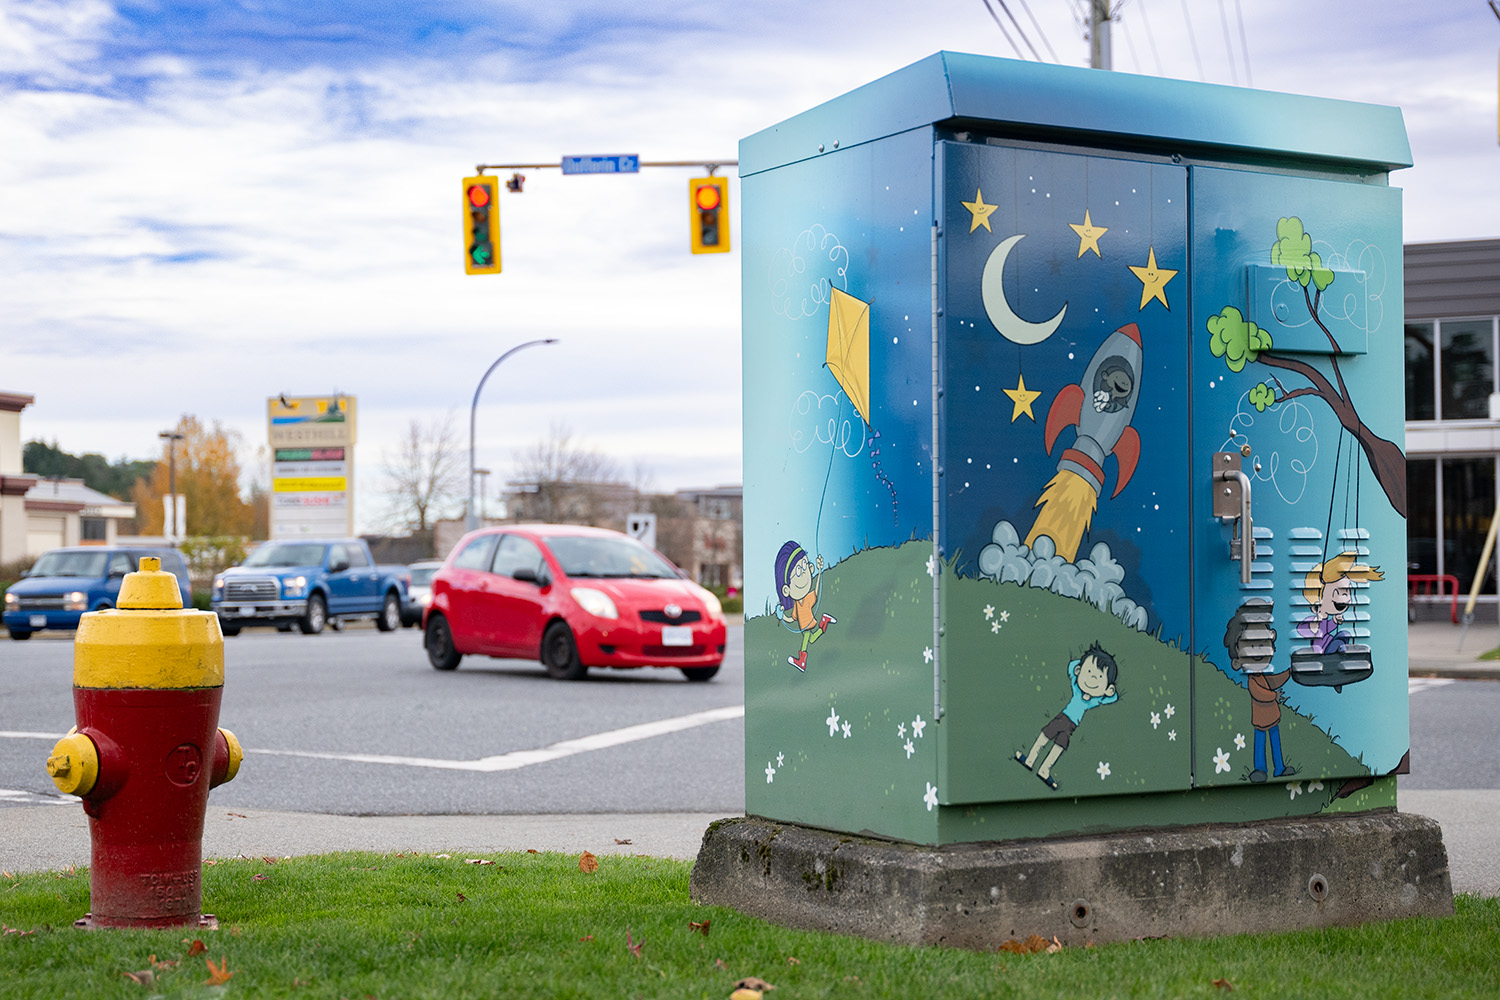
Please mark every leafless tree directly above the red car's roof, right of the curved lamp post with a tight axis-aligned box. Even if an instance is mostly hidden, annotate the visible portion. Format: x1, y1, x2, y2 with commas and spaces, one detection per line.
507, 423, 635, 528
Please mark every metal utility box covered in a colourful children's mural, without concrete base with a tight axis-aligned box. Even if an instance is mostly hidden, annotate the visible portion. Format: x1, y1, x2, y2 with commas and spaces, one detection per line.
740, 52, 1410, 844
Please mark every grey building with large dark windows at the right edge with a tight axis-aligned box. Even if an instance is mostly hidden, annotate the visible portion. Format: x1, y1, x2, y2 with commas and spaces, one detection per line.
1403, 240, 1500, 616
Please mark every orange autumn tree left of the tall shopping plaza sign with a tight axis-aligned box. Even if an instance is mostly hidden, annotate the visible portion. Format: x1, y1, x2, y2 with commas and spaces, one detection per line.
131, 414, 255, 537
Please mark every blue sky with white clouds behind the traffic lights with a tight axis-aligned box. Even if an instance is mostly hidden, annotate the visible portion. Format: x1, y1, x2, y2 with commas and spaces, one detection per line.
0, 0, 1500, 528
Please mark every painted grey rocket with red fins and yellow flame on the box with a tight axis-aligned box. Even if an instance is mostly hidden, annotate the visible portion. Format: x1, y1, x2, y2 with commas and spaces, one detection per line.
1026, 322, 1142, 562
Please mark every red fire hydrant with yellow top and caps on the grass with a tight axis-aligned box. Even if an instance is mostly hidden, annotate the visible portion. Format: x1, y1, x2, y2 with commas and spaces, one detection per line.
47, 556, 243, 928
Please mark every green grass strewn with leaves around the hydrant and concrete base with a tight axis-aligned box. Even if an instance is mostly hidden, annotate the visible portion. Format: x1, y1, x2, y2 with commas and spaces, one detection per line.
0, 853, 1500, 1000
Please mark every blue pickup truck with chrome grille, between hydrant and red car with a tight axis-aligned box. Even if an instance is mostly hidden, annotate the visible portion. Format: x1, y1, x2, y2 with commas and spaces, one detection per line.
212, 538, 408, 636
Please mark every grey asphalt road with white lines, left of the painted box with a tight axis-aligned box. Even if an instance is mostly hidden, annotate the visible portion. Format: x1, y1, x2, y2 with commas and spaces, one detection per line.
0, 627, 744, 816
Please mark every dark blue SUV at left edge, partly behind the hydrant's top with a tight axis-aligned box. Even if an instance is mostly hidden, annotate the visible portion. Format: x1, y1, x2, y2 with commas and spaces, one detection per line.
5, 546, 192, 639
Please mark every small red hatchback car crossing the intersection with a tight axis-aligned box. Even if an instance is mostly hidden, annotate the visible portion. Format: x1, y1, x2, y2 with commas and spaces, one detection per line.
423, 525, 726, 681
